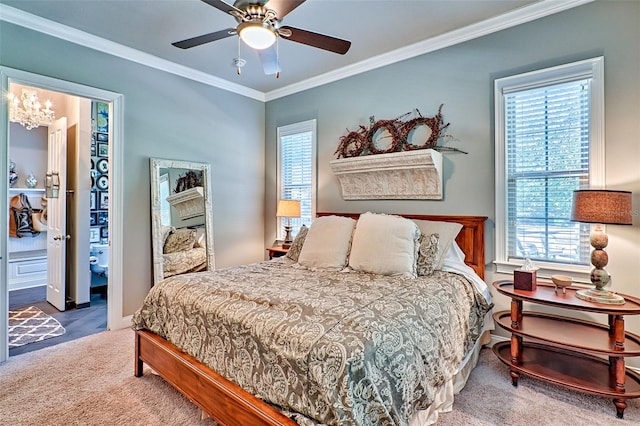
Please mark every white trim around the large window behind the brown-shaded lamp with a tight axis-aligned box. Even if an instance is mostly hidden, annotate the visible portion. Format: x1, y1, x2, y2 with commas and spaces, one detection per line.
494, 56, 605, 283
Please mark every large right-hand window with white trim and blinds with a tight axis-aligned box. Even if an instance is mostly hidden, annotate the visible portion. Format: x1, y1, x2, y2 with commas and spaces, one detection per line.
495, 58, 604, 281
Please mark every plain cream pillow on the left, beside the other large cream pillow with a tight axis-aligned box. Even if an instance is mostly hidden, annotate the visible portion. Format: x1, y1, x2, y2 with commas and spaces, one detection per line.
298, 216, 356, 270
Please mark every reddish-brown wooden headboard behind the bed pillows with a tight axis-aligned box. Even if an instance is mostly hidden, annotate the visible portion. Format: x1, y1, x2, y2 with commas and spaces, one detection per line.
316, 212, 487, 279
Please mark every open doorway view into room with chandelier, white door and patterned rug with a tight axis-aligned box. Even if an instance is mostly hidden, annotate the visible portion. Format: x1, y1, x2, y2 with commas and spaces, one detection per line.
8, 83, 109, 356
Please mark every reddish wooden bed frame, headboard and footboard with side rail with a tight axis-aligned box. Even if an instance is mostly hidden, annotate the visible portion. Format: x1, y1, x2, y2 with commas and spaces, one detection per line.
134, 213, 487, 426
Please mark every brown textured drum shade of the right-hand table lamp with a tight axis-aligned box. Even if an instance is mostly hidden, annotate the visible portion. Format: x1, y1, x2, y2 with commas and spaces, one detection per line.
571, 189, 632, 225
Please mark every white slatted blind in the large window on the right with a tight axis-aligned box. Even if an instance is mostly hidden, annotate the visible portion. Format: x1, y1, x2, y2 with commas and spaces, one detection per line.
505, 79, 590, 265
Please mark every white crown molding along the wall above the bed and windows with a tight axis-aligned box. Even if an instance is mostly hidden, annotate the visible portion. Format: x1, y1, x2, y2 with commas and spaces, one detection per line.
265, 0, 595, 102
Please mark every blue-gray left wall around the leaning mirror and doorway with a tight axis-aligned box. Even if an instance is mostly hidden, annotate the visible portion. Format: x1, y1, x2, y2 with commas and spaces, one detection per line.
0, 21, 265, 316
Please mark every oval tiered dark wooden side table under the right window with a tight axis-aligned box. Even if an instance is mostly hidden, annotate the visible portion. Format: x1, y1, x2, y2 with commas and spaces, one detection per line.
493, 281, 640, 418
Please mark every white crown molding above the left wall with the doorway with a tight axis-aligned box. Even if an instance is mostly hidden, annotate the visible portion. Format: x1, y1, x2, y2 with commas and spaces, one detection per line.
0, 4, 265, 102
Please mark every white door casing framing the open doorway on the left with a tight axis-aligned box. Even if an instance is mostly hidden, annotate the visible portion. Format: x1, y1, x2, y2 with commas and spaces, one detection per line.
0, 67, 129, 362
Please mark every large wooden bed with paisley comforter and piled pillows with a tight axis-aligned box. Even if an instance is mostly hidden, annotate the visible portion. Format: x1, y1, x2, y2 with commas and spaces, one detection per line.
133, 213, 492, 425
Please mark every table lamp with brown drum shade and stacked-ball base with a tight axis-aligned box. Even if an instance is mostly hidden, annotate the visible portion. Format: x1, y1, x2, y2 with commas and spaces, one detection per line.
571, 189, 632, 305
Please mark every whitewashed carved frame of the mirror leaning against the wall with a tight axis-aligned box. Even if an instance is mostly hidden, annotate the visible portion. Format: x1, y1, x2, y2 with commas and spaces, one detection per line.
149, 157, 215, 284
